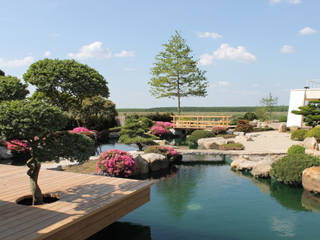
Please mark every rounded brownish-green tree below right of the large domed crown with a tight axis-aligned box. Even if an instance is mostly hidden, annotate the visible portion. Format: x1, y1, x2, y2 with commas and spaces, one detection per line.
79, 96, 118, 131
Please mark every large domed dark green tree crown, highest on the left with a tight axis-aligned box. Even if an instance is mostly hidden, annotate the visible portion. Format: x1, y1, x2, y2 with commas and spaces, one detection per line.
23, 59, 109, 113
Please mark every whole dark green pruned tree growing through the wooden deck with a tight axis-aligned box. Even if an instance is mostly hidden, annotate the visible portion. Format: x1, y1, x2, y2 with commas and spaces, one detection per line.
0, 100, 95, 205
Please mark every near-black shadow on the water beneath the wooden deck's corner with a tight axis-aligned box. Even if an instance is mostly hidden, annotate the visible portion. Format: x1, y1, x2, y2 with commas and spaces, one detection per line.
88, 222, 151, 240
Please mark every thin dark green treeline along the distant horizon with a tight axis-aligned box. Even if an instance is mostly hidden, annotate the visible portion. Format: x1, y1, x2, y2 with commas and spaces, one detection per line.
117, 106, 288, 113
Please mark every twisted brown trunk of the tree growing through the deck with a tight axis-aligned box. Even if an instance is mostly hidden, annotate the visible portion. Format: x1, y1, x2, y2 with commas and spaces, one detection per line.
27, 157, 43, 205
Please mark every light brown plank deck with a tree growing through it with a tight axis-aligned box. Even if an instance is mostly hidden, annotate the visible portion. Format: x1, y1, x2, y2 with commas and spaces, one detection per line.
0, 164, 151, 240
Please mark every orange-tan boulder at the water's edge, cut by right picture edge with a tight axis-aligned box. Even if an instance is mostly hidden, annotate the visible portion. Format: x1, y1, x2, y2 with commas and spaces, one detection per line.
302, 167, 320, 193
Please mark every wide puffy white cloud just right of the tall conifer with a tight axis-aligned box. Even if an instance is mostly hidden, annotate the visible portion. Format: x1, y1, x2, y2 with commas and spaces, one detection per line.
199, 43, 257, 65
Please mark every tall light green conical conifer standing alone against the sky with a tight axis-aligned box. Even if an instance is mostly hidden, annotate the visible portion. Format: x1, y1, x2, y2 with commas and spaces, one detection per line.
149, 31, 208, 113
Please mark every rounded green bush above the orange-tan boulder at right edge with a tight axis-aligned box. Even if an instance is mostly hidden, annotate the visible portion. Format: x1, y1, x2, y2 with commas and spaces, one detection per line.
270, 154, 320, 185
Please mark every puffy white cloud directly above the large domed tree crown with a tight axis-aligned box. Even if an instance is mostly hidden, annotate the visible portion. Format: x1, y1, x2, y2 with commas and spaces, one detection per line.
68, 41, 111, 60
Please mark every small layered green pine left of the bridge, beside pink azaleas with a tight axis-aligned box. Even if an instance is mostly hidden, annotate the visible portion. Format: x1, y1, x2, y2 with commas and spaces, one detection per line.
119, 117, 158, 151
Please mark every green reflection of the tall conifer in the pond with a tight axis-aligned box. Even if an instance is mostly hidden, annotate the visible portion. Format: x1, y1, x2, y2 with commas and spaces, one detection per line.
156, 166, 206, 217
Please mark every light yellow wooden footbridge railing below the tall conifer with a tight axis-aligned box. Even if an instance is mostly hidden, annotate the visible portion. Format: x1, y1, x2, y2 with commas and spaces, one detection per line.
172, 115, 231, 129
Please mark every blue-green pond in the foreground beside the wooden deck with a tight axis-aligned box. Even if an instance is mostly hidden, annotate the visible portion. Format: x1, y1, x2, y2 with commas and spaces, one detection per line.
90, 162, 320, 240
